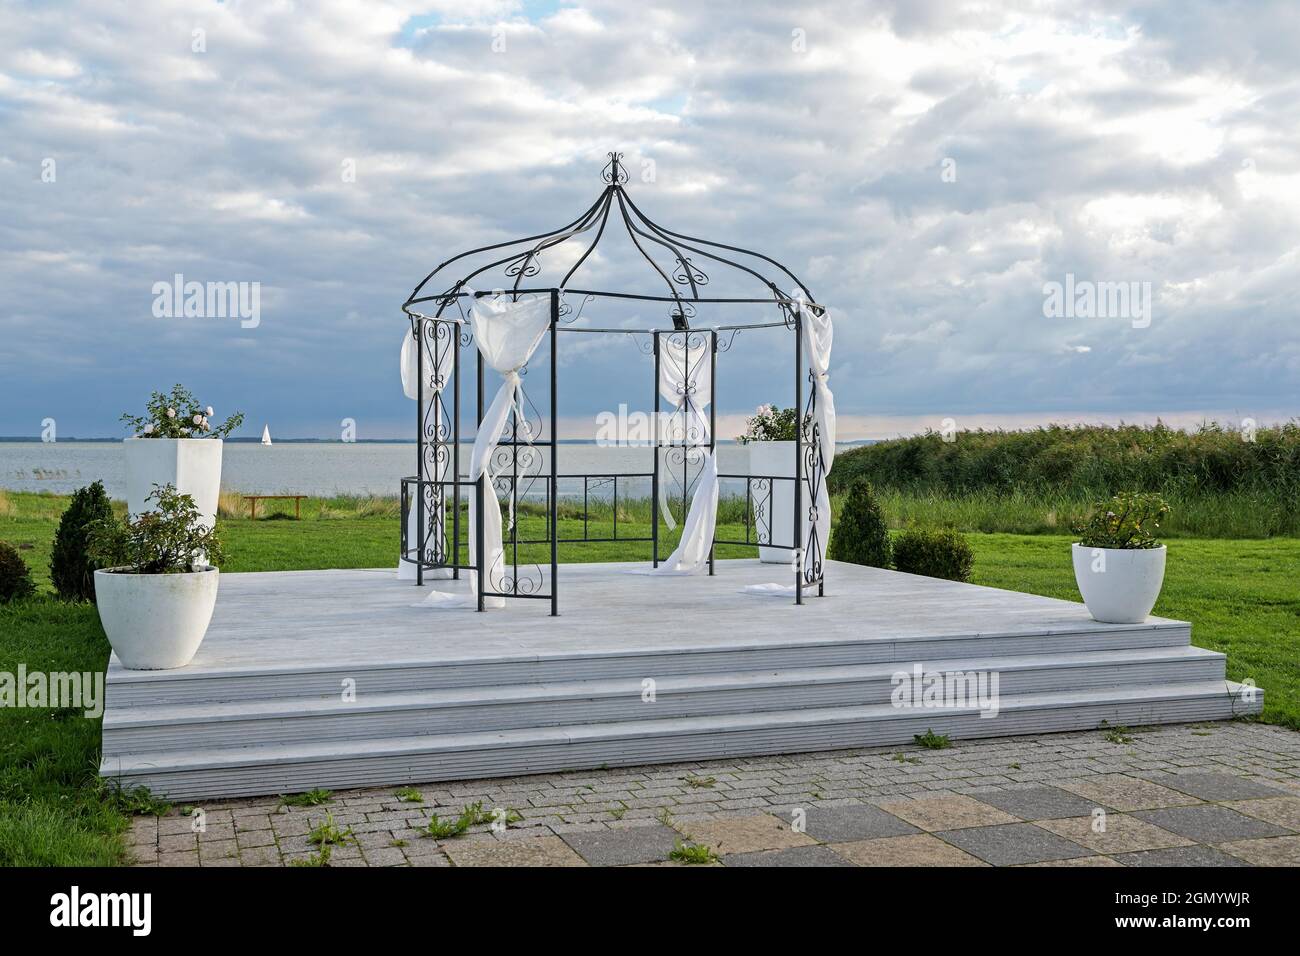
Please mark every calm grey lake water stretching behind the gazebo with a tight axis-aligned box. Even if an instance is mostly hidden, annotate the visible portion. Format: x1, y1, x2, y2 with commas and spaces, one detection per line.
0, 441, 852, 498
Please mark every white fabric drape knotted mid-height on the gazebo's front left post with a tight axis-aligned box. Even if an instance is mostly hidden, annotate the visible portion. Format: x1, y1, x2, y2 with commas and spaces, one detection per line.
424, 287, 554, 607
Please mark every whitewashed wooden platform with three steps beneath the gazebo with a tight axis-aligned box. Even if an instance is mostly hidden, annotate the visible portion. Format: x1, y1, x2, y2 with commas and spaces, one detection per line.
101, 561, 1262, 799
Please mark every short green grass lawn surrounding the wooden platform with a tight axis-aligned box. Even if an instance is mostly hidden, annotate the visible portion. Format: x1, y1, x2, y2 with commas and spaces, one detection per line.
0, 493, 1300, 866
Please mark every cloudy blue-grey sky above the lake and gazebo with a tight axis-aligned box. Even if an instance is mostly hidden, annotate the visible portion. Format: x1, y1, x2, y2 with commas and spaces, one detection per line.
0, 0, 1300, 438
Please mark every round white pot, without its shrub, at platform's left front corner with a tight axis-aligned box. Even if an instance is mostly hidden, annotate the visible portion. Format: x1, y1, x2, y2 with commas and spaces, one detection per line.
95, 567, 221, 671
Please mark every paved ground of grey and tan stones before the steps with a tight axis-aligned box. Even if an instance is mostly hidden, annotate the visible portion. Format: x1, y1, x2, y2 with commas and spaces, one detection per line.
127, 722, 1300, 866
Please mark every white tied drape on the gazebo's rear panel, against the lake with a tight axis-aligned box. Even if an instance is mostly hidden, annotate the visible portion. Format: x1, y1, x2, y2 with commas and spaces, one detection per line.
650, 332, 718, 575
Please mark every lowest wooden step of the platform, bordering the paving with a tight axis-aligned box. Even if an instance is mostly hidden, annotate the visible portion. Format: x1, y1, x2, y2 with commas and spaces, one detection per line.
100, 680, 1264, 800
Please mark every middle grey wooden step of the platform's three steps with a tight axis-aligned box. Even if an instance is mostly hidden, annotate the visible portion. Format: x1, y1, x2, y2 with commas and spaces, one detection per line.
104, 646, 1225, 756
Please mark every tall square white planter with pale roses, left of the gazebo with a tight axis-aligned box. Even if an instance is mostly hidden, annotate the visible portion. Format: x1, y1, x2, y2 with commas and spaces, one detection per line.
122, 385, 243, 528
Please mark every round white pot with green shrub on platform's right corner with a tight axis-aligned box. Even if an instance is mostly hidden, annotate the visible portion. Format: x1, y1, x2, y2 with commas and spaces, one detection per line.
1074, 493, 1169, 624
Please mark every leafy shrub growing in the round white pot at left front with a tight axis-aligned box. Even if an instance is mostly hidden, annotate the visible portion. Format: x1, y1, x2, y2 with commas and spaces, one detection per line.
88, 485, 225, 575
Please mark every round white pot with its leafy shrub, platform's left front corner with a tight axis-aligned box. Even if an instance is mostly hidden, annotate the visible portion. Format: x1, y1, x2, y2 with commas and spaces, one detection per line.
90, 485, 221, 670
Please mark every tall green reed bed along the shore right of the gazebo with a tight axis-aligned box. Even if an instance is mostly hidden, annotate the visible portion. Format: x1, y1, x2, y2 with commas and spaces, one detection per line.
831, 423, 1300, 538
